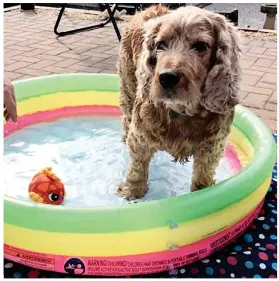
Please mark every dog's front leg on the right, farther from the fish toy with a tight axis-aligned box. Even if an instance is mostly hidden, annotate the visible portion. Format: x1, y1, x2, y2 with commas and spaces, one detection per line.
191, 139, 226, 191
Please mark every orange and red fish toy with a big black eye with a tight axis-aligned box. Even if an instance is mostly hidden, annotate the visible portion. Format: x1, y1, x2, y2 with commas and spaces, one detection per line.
29, 167, 65, 205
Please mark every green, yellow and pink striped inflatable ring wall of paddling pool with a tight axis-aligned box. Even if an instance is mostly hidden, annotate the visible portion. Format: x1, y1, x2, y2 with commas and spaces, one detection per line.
4, 74, 276, 276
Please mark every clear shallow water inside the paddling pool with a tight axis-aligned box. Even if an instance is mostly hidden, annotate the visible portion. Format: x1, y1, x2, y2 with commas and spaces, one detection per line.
3, 116, 232, 206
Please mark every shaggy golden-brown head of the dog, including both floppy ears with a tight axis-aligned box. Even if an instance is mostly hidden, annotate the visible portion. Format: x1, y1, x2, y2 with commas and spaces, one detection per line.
143, 6, 240, 116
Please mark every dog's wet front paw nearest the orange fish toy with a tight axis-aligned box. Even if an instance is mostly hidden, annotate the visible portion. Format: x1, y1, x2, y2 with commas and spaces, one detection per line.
116, 181, 148, 201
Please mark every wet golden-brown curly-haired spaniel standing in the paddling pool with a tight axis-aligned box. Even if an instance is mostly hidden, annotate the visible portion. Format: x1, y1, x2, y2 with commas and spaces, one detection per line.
116, 4, 241, 200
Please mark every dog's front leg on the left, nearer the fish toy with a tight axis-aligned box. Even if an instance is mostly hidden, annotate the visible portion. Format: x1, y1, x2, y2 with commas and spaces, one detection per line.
116, 133, 155, 200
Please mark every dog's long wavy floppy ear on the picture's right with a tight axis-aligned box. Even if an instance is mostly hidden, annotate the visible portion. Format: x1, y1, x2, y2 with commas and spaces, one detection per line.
201, 13, 241, 113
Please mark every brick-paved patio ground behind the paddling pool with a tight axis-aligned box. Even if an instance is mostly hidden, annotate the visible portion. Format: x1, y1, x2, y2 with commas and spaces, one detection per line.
4, 7, 277, 131
